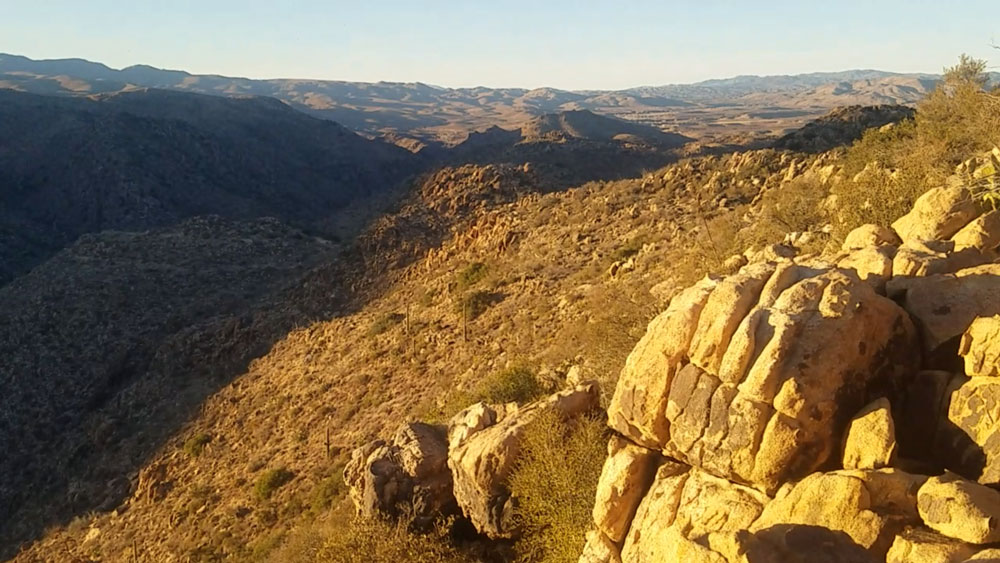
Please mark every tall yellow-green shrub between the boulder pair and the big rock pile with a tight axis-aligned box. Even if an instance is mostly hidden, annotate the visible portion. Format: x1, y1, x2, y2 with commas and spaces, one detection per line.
510, 412, 607, 563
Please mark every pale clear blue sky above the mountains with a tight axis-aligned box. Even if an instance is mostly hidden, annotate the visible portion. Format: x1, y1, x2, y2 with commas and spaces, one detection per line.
0, 0, 1000, 90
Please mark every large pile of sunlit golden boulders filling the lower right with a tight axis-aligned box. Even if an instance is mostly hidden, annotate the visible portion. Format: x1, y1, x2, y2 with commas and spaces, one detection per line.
580, 186, 1000, 563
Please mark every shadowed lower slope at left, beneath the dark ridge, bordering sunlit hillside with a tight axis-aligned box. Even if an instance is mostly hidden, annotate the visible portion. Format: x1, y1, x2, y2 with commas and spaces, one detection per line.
0, 217, 352, 560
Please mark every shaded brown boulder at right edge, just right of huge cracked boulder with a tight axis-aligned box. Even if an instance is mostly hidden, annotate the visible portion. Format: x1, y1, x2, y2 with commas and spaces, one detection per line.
886, 264, 1000, 353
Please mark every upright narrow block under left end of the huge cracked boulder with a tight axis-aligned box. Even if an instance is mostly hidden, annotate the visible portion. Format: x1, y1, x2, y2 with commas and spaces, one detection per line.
593, 436, 660, 544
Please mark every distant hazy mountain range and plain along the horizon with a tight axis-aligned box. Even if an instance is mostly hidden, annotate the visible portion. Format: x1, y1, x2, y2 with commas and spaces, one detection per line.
0, 54, 1000, 144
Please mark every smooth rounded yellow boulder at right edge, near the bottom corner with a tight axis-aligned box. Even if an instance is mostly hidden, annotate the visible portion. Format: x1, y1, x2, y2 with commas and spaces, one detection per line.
917, 473, 1000, 544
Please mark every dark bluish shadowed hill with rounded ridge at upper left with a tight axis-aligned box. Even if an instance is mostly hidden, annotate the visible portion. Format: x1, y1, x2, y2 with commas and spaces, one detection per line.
0, 90, 420, 284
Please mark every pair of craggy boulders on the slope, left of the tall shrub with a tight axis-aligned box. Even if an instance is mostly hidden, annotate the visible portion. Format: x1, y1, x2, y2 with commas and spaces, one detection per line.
344, 383, 599, 539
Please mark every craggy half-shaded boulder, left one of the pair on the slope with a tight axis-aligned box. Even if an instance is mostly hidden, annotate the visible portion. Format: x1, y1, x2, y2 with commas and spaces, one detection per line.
344, 422, 456, 527
